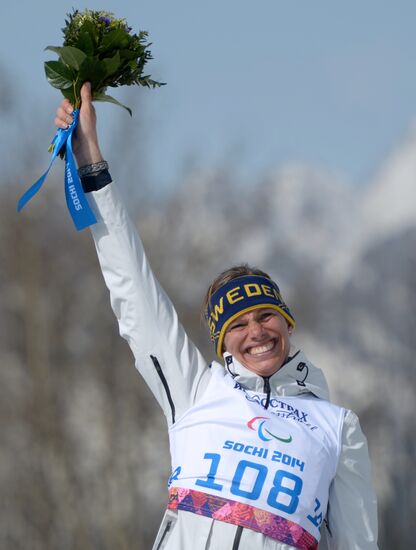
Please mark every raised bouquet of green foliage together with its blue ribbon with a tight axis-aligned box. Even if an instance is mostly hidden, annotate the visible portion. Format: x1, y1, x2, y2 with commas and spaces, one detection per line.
17, 9, 163, 230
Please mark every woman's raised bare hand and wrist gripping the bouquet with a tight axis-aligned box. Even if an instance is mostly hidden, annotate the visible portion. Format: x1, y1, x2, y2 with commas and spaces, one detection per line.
55, 82, 103, 166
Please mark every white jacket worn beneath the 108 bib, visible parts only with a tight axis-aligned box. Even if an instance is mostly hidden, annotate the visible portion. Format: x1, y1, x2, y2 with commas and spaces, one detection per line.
88, 183, 377, 550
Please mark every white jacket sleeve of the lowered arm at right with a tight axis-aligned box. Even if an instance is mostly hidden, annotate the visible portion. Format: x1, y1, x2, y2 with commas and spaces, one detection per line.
319, 411, 378, 550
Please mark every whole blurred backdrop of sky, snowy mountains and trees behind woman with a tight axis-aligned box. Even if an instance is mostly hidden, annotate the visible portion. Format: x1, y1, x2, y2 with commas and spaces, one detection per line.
0, 0, 416, 550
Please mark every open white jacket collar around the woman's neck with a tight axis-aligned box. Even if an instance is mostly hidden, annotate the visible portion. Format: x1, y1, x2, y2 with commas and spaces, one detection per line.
224, 350, 329, 400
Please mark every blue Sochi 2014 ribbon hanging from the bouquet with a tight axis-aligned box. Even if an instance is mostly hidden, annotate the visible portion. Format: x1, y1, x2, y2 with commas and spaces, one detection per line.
17, 109, 97, 231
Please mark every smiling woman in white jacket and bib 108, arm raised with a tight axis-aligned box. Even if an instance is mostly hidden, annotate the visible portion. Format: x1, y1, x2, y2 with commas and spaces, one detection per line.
55, 84, 377, 550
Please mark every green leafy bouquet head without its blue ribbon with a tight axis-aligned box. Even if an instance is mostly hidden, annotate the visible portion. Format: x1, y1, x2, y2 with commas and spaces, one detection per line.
45, 9, 164, 115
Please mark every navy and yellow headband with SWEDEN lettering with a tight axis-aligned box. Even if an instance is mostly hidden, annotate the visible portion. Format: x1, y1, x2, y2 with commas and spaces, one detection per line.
205, 275, 296, 357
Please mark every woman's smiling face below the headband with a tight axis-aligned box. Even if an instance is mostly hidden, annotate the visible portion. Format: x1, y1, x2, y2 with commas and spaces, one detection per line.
224, 308, 293, 376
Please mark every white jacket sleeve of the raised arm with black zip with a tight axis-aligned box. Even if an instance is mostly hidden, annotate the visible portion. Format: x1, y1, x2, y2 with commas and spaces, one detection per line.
88, 183, 209, 423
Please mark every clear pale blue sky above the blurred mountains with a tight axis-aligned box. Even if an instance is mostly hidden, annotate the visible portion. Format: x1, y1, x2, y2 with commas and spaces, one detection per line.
0, 0, 416, 186
